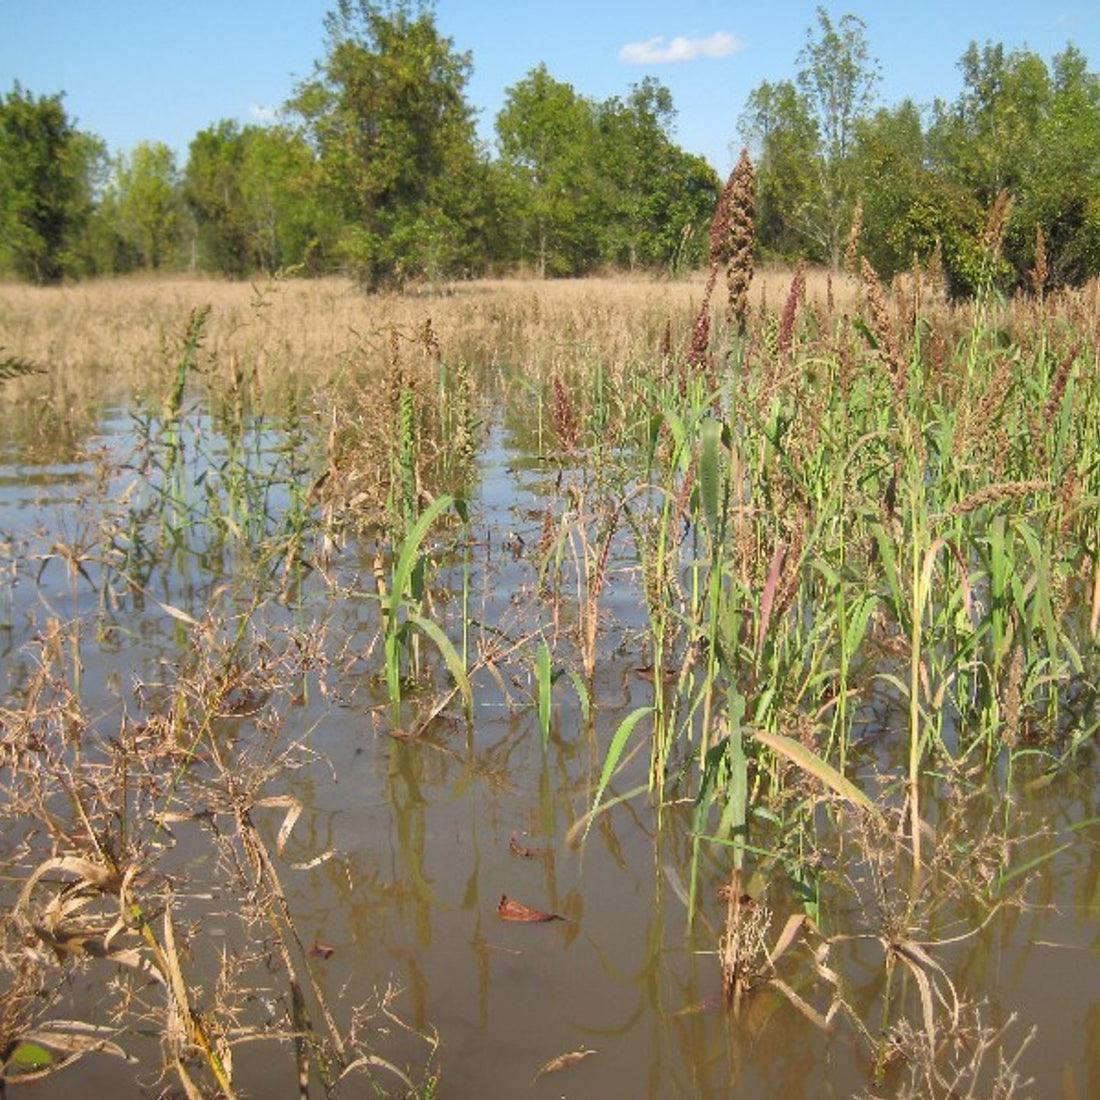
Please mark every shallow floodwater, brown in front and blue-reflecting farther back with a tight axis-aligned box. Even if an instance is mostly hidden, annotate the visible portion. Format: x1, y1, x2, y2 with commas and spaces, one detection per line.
0, 389, 1100, 1100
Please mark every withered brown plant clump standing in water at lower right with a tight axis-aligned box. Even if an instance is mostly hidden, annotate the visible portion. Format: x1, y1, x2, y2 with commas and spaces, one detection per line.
699, 799, 1035, 1100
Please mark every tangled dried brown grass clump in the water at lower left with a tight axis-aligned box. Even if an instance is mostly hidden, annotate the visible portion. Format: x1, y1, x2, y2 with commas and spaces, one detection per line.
0, 592, 435, 1098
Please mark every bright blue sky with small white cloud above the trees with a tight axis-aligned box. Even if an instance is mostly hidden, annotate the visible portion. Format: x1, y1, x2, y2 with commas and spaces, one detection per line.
0, 0, 1100, 175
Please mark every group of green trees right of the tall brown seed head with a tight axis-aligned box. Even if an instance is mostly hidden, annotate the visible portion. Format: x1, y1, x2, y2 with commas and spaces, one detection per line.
740, 9, 1100, 294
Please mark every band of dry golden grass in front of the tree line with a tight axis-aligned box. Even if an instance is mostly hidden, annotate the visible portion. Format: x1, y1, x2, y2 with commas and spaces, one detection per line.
0, 268, 855, 391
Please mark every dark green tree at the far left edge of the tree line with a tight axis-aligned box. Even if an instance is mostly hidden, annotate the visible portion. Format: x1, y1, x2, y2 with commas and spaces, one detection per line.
0, 81, 103, 283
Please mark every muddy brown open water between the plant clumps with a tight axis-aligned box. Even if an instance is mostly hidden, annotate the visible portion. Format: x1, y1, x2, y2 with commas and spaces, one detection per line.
0, 413, 1100, 1100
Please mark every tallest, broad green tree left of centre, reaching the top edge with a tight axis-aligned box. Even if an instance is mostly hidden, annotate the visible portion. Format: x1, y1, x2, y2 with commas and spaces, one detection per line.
287, 0, 484, 287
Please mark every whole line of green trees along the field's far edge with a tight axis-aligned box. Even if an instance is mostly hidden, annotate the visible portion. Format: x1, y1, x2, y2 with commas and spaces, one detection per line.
0, 0, 1100, 294
